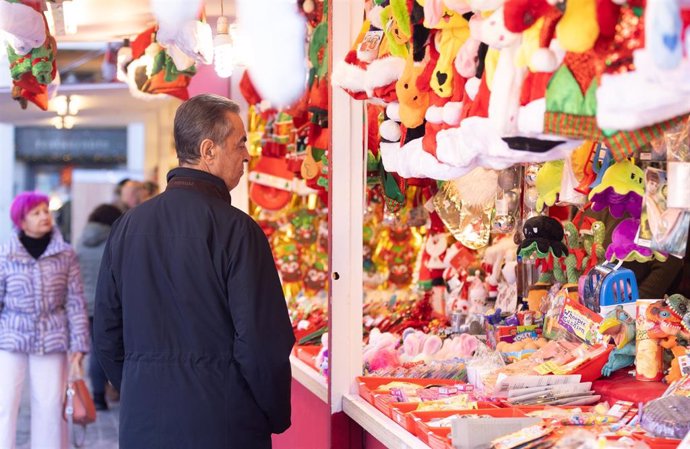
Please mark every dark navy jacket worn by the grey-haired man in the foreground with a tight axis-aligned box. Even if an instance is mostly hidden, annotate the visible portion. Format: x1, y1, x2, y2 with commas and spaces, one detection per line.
94, 168, 294, 449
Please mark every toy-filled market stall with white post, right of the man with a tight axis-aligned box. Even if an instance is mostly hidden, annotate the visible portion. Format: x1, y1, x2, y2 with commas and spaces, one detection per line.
330, 1, 690, 447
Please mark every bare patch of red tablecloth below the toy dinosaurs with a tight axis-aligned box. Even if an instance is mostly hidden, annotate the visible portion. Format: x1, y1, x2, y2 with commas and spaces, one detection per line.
592, 368, 668, 405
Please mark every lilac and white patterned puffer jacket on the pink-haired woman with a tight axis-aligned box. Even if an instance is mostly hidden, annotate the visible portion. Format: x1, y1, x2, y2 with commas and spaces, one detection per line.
0, 230, 90, 354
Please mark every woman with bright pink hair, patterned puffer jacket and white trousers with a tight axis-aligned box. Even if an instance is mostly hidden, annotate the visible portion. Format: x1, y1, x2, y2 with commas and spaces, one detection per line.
0, 192, 91, 449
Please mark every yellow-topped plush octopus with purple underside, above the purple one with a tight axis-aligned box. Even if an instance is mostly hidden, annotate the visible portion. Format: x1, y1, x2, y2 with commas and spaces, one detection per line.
589, 159, 644, 218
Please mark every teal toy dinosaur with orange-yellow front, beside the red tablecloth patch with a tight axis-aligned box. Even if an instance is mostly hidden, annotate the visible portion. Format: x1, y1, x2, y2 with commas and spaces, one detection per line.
599, 306, 635, 377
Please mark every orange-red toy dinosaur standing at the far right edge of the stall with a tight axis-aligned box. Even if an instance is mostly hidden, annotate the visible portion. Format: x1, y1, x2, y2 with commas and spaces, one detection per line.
647, 295, 690, 384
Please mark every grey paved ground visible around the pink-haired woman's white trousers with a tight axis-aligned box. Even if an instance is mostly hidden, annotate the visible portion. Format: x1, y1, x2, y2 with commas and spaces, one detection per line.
17, 360, 120, 449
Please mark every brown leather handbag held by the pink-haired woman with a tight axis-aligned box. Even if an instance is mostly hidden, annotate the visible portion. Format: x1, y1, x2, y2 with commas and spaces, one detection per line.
62, 367, 96, 448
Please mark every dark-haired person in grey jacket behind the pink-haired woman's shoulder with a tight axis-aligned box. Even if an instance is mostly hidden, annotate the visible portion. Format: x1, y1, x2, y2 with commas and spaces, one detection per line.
76, 204, 122, 410
